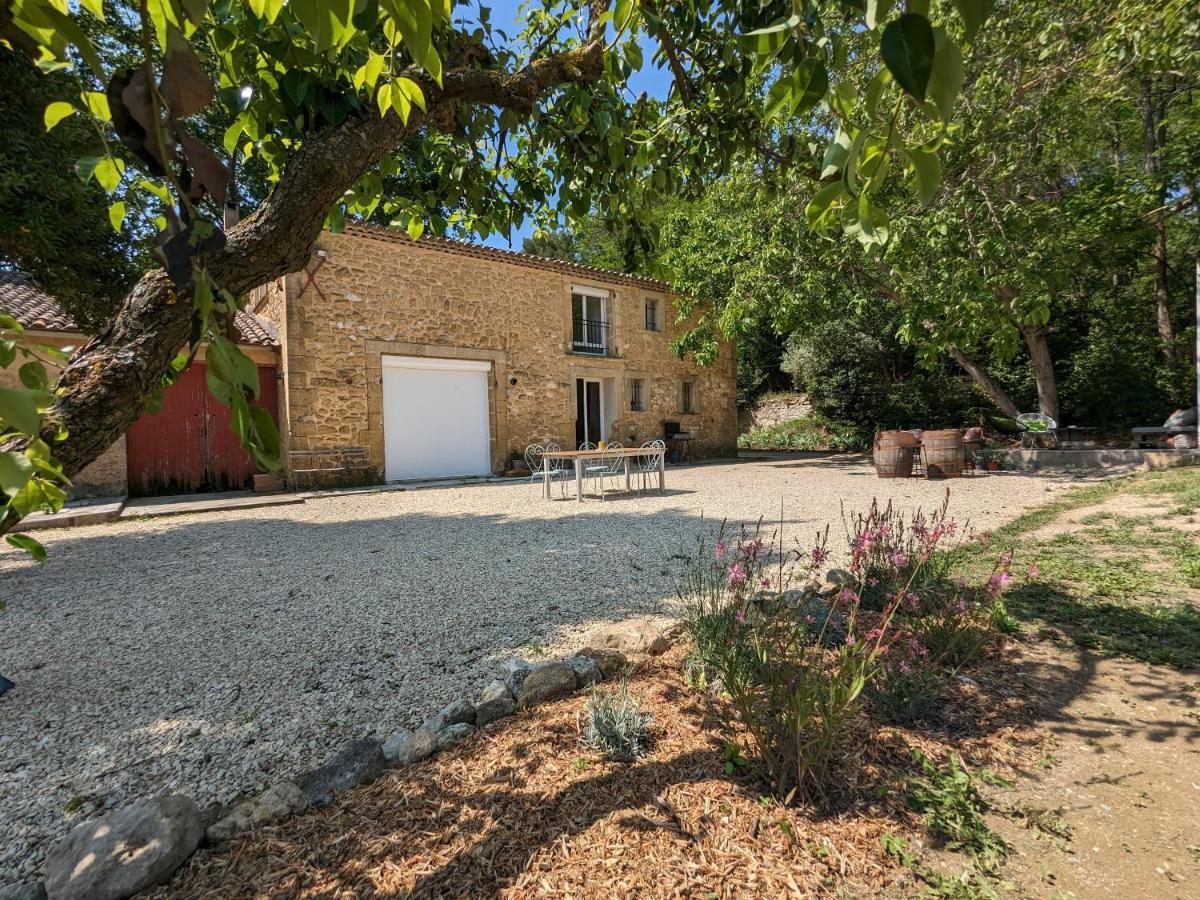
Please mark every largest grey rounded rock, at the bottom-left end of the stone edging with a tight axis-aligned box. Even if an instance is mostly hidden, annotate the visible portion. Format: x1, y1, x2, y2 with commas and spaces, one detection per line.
46, 794, 204, 900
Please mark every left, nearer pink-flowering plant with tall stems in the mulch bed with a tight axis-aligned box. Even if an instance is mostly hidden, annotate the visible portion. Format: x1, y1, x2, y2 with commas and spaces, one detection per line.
679, 526, 894, 802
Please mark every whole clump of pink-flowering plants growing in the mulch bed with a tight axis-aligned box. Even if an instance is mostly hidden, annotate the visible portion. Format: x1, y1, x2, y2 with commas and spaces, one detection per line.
678, 503, 1027, 803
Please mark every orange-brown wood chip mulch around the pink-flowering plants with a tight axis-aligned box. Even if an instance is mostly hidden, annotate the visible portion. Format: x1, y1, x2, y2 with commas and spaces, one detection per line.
151, 647, 1042, 898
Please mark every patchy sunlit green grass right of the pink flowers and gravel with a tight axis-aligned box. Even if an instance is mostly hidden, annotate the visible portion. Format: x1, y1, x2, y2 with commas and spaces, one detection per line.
954, 468, 1200, 668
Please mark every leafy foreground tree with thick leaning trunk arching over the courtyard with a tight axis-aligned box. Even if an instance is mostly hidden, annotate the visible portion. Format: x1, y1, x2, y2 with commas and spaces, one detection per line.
0, 0, 991, 554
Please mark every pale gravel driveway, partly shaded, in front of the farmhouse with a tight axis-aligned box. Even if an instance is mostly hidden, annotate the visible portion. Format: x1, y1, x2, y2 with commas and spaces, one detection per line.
0, 457, 1069, 884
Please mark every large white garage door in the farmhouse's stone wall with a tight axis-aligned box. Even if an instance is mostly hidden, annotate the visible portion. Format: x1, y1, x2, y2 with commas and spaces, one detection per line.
383, 356, 492, 481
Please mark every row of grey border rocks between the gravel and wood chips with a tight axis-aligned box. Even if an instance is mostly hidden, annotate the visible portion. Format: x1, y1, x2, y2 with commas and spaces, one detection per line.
28, 619, 678, 900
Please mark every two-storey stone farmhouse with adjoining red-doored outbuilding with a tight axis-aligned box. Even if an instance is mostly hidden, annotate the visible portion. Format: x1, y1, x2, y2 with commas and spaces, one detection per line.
0, 224, 737, 494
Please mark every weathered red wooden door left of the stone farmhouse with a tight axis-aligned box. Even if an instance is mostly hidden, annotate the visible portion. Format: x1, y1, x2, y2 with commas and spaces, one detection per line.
125, 362, 278, 497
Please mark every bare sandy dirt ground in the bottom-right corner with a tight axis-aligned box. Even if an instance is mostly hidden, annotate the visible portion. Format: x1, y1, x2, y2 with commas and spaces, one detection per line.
989, 642, 1200, 900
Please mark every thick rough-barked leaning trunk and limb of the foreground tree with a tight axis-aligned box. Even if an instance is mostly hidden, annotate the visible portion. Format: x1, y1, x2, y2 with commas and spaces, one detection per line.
0, 19, 607, 532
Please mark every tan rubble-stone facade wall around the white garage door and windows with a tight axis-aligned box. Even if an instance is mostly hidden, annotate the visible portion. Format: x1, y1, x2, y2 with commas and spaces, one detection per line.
271, 229, 737, 480
